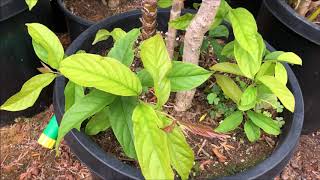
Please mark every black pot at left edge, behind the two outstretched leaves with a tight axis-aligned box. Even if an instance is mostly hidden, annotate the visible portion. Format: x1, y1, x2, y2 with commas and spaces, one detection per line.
0, 0, 52, 126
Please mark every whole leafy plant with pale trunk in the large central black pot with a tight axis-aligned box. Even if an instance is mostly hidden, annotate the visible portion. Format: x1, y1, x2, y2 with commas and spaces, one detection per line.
1, 1, 303, 179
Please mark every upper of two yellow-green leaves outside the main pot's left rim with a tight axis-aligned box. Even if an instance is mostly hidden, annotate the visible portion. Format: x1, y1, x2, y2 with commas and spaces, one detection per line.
26, 23, 64, 69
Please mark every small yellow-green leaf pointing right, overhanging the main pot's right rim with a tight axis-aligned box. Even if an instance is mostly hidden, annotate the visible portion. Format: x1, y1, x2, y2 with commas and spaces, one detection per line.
264, 51, 302, 65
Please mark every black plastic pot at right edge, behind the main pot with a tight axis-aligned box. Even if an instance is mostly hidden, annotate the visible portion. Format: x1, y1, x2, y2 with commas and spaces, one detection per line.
257, 0, 320, 134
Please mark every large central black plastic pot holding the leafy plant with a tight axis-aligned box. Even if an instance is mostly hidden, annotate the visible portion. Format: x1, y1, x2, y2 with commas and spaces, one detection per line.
54, 10, 304, 179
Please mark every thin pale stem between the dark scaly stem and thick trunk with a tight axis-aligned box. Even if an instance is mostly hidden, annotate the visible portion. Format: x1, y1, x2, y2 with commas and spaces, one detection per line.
167, 0, 183, 59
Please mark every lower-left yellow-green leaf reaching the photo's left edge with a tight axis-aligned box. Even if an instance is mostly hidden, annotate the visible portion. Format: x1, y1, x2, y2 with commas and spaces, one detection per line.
0, 73, 56, 111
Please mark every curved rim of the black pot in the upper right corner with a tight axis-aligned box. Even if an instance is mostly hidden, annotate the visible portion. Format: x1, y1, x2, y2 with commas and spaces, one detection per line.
263, 0, 320, 45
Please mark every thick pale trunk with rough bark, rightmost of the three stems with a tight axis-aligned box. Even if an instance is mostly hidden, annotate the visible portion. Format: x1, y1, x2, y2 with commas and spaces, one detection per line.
175, 0, 220, 111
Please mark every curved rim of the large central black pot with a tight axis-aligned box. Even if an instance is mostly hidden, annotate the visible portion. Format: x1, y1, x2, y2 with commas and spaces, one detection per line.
54, 10, 304, 179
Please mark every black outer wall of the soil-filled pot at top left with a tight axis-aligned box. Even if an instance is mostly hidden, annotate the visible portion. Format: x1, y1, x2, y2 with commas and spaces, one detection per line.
57, 0, 94, 41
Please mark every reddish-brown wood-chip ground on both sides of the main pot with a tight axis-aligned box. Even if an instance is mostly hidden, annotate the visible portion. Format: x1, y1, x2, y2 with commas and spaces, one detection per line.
0, 107, 320, 180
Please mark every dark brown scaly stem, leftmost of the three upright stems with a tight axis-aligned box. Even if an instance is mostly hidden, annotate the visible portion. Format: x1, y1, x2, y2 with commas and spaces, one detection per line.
140, 0, 157, 40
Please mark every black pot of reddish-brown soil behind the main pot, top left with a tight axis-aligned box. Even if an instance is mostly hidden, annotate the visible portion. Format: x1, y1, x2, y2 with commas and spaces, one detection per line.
57, 0, 141, 40
